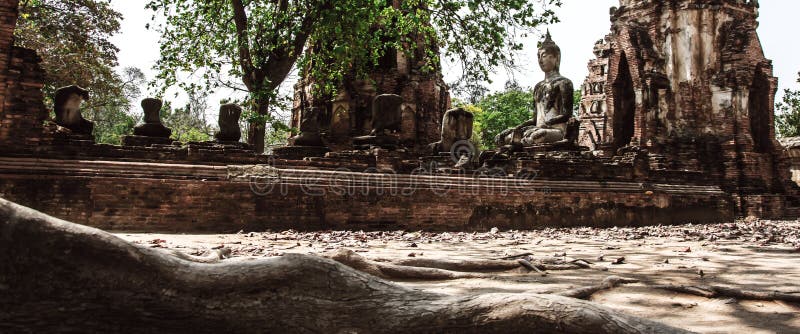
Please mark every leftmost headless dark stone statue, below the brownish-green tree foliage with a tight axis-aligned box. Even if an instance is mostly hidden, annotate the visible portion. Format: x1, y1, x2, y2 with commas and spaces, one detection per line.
53, 85, 94, 136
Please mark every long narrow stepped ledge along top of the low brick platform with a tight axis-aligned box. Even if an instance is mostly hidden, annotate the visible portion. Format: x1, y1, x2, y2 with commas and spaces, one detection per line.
0, 158, 724, 195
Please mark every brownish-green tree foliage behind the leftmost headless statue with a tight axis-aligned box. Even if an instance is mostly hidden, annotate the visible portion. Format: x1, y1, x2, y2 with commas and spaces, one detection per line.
14, 0, 144, 144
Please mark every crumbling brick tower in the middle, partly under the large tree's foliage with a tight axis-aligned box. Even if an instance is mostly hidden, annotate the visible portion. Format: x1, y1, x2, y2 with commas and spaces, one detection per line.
291, 1, 450, 150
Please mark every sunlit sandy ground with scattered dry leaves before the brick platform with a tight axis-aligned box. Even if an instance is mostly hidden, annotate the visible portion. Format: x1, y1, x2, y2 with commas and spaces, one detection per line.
118, 221, 800, 334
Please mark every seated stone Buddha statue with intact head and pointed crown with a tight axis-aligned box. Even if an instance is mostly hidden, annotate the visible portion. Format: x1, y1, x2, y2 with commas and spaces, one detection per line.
495, 31, 573, 147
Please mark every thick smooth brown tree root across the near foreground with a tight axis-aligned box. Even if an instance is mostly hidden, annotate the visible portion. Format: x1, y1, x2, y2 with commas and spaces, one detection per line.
0, 199, 685, 333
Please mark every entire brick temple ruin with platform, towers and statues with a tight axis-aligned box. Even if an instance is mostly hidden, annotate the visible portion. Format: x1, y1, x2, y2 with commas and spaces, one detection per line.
0, 0, 798, 232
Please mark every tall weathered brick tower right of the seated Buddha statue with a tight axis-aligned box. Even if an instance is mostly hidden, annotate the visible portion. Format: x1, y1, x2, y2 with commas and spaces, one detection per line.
581, 0, 790, 214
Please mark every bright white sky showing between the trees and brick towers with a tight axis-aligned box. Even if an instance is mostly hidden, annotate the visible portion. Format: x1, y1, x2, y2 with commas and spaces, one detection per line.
111, 0, 800, 119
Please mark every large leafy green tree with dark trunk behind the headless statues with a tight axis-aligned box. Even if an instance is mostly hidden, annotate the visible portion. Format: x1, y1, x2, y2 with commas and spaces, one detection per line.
147, 0, 560, 149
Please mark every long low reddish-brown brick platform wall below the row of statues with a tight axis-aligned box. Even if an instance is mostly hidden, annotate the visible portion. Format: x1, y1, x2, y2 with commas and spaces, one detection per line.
0, 158, 736, 233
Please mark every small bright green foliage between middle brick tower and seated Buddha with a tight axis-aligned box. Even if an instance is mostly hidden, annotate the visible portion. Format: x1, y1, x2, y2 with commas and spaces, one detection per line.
462, 82, 535, 149
